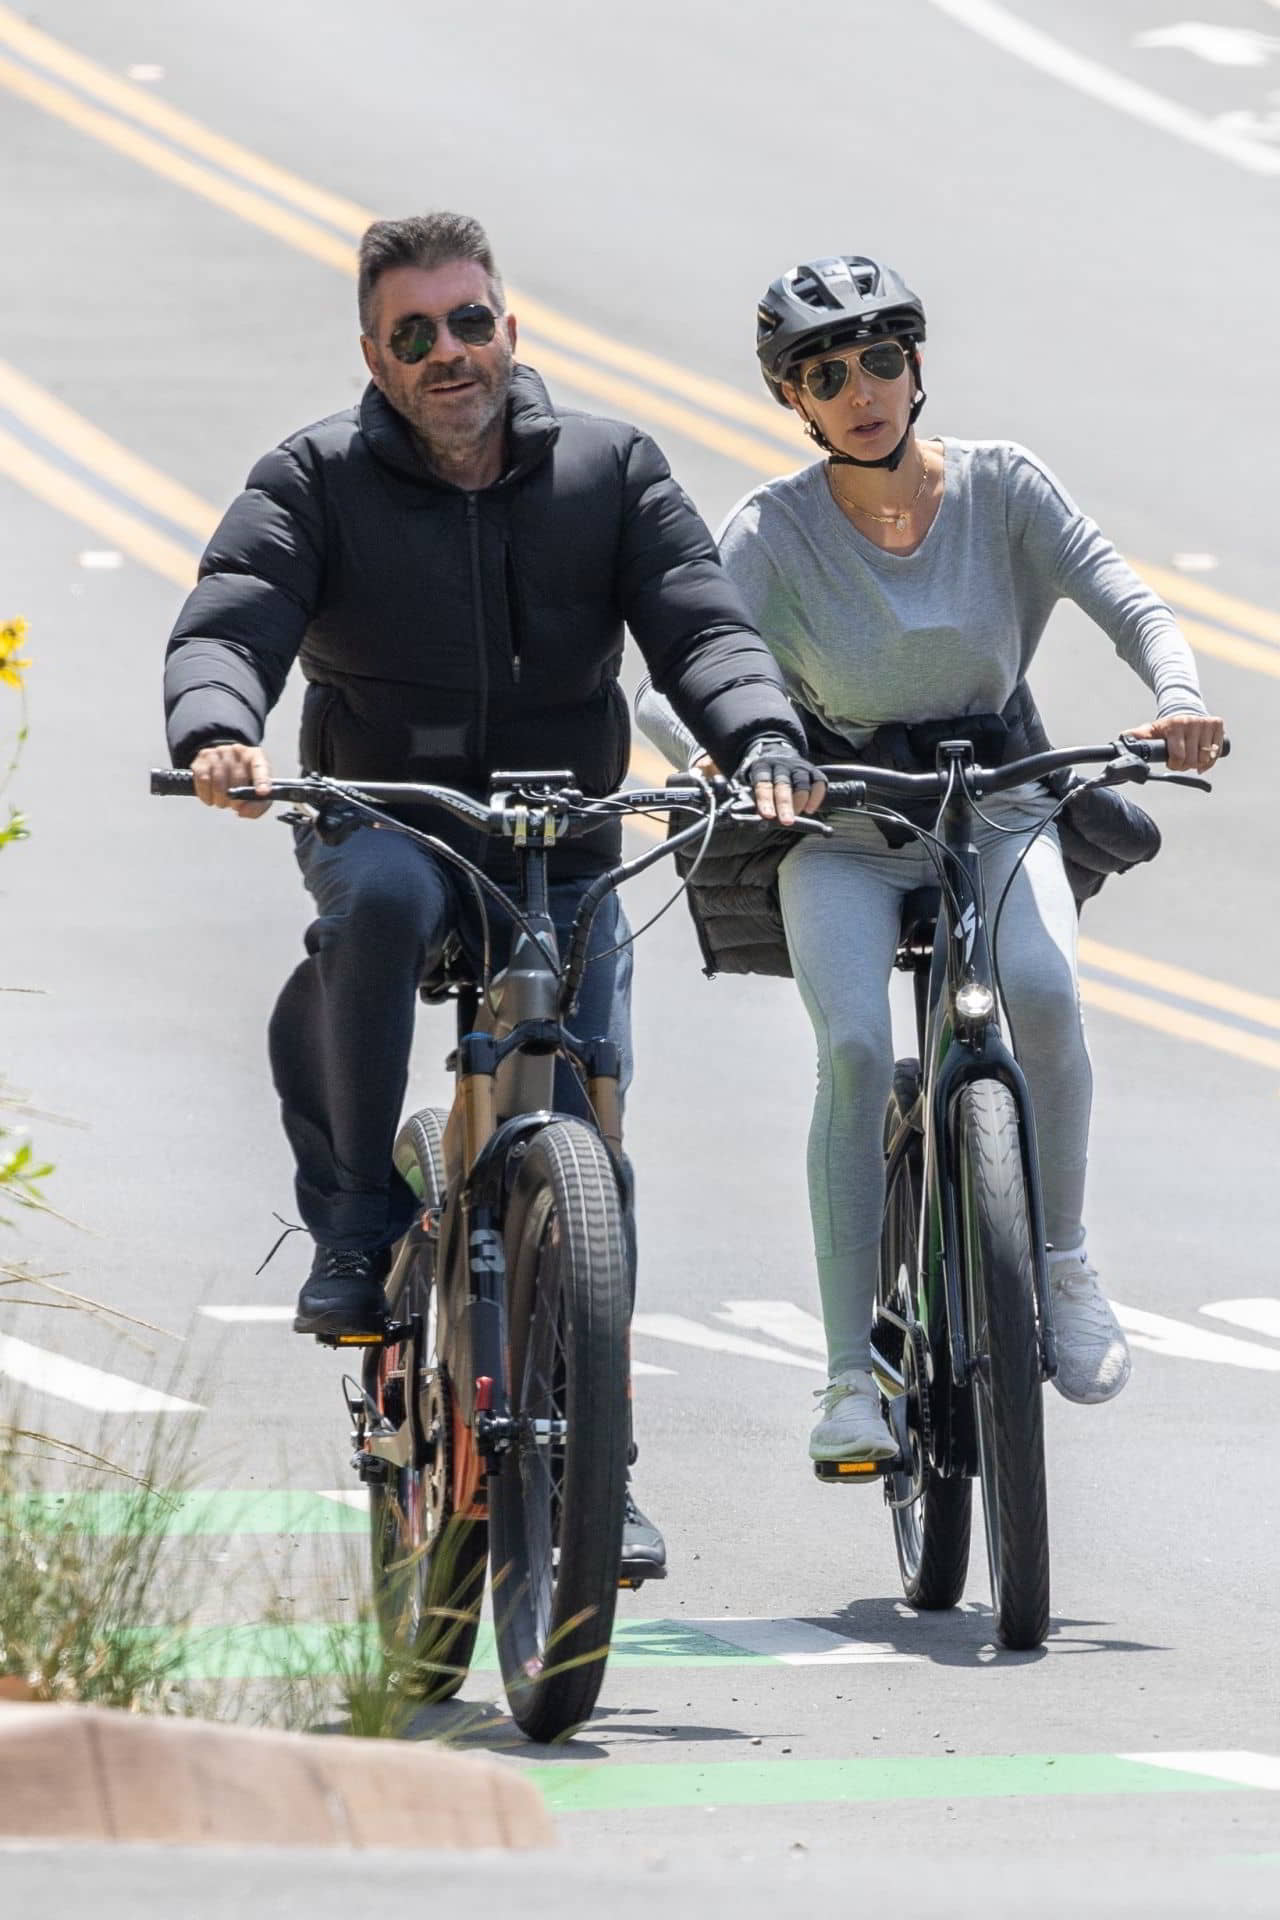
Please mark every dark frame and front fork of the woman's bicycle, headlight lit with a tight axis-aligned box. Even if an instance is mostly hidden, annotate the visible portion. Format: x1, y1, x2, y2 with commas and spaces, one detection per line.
889, 741, 1057, 1473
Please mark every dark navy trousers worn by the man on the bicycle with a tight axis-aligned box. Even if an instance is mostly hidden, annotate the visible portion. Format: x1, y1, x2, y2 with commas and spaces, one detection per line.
271, 826, 631, 1250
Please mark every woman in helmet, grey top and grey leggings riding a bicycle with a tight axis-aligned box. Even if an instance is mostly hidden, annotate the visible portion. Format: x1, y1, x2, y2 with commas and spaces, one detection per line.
637, 255, 1222, 1459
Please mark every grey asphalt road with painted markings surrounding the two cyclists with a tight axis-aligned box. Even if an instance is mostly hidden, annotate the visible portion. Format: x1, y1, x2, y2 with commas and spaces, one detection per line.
0, 0, 1280, 1914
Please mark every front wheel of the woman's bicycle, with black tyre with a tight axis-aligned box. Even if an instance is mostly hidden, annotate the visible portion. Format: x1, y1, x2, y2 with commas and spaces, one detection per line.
956, 1081, 1050, 1649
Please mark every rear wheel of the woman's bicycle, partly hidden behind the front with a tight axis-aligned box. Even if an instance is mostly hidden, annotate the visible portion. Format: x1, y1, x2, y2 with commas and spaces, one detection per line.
875, 1060, 973, 1613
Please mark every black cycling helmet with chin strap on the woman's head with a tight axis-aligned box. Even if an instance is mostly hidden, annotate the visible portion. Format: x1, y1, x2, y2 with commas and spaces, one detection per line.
756, 253, 925, 470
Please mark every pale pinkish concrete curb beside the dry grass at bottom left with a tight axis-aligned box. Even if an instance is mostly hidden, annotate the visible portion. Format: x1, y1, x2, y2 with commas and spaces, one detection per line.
0, 1703, 557, 1849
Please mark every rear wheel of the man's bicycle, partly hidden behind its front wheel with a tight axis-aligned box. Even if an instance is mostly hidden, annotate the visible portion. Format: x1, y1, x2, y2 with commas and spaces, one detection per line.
368, 1108, 487, 1699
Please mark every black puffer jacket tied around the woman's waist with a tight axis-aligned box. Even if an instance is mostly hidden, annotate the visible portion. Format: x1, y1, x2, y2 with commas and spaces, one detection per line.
674, 682, 1161, 975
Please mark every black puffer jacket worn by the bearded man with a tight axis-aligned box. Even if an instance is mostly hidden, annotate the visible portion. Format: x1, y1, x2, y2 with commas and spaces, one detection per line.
165, 367, 804, 877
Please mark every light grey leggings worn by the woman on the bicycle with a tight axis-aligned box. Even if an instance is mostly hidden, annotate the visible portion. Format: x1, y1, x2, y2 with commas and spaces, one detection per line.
781, 789, 1092, 1375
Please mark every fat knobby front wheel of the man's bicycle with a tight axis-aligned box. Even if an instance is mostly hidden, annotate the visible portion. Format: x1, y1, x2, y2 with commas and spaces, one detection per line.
489, 1119, 629, 1740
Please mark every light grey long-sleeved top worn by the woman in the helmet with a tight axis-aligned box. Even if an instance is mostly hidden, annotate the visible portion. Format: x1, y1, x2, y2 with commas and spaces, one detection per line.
637, 440, 1205, 764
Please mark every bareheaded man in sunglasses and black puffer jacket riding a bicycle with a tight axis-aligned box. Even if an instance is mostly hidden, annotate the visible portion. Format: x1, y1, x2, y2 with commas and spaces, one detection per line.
165, 213, 821, 1561
